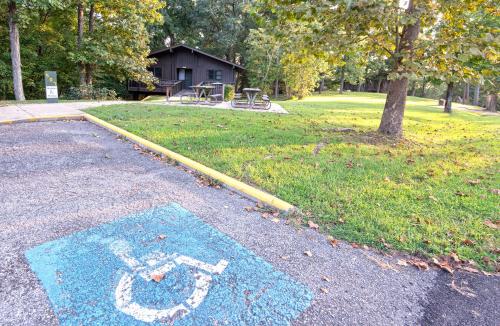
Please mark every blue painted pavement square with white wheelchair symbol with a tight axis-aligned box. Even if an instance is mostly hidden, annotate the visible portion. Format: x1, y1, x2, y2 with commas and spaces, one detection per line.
26, 203, 313, 325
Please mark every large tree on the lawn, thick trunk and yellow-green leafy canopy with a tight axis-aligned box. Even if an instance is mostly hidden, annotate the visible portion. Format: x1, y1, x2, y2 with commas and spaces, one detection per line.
261, 0, 496, 136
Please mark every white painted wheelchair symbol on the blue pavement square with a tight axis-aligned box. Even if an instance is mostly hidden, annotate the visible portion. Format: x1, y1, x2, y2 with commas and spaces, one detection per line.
110, 240, 228, 322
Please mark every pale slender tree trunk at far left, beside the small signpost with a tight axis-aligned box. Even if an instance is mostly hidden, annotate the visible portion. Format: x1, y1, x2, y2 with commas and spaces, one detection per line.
8, 1, 26, 101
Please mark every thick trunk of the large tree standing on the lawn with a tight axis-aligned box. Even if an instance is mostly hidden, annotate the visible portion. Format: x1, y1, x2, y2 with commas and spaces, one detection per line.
378, 0, 420, 136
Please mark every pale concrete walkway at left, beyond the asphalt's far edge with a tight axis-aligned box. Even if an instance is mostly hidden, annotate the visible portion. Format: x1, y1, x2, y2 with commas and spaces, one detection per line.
0, 101, 130, 122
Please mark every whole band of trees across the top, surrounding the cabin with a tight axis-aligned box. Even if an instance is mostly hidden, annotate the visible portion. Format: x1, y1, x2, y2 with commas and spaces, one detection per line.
0, 0, 500, 136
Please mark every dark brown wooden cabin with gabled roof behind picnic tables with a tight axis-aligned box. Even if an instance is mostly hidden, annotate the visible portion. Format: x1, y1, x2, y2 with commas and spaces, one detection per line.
128, 45, 245, 98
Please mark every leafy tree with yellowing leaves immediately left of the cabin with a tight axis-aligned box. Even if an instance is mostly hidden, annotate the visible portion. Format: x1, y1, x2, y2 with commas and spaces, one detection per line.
70, 0, 163, 85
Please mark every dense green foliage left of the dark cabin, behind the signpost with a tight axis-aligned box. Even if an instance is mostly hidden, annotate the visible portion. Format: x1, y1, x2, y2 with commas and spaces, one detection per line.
0, 0, 162, 99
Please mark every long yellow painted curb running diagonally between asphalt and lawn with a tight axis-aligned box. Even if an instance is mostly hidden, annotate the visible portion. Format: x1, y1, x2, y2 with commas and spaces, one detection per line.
83, 113, 294, 211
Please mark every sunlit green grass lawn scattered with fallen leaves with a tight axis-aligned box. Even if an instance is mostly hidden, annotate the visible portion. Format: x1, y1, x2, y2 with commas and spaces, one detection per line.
89, 93, 500, 270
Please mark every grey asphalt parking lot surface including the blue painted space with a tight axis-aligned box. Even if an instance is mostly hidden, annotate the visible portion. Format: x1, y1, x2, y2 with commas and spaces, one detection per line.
0, 121, 500, 325
